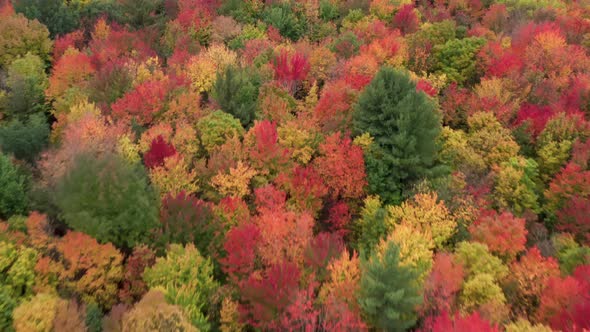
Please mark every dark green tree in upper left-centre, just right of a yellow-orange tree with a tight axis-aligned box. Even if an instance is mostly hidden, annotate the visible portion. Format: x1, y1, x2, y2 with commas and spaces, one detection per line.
212, 66, 258, 128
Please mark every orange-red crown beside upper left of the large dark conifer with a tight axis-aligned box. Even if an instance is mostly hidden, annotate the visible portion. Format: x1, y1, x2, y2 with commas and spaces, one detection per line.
314, 80, 354, 132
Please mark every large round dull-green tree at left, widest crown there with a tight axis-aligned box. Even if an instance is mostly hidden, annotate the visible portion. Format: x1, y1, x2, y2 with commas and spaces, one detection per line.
55, 154, 158, 248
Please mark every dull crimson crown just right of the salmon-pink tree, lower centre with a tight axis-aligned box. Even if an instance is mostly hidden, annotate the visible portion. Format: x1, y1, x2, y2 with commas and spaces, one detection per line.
305, 232, 344, 277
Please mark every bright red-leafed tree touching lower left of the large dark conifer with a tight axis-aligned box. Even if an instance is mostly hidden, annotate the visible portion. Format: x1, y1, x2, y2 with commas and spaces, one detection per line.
314, 133, 367, 199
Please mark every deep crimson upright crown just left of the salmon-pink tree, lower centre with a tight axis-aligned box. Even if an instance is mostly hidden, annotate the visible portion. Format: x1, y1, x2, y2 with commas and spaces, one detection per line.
221, 223, 260, 285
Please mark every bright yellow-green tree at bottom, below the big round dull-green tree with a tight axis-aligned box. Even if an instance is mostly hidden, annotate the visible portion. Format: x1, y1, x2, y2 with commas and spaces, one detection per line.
143, 244, 218, 330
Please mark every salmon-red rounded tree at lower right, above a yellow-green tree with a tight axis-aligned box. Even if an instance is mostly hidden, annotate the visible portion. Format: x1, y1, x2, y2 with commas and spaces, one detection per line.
469, 210, 528, 258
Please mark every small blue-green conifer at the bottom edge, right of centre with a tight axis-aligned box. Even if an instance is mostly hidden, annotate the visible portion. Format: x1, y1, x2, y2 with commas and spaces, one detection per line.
358, 241, 422, 331
